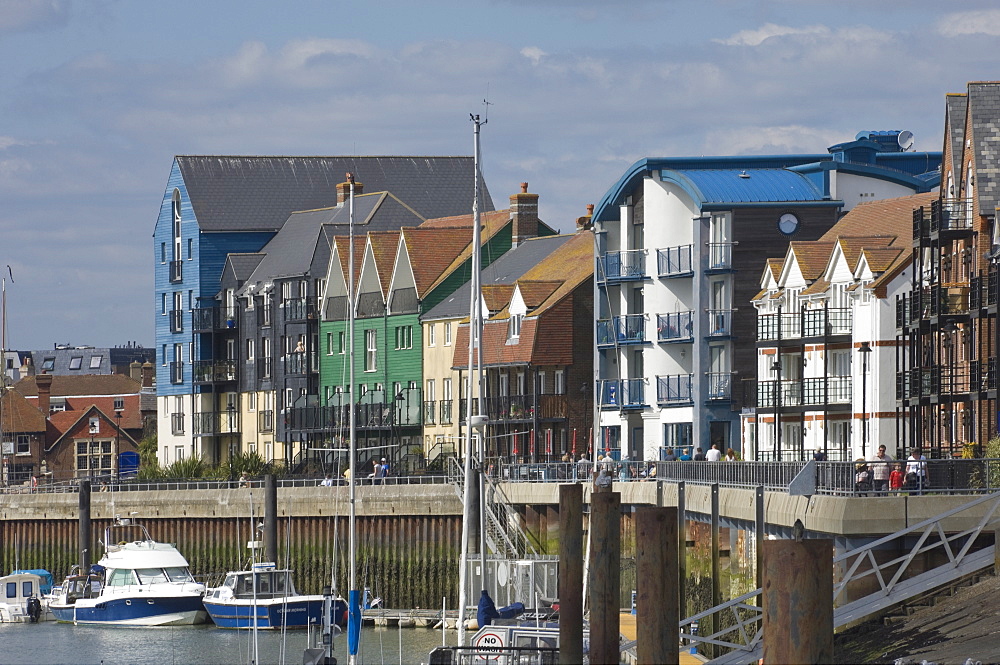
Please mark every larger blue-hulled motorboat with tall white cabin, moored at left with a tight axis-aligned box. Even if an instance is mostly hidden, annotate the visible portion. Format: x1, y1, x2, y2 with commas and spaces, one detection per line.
49, 518, 208, 626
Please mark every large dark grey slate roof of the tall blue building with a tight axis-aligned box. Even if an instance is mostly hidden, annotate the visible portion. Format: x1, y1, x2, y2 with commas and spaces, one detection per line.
175, 155, 493, 232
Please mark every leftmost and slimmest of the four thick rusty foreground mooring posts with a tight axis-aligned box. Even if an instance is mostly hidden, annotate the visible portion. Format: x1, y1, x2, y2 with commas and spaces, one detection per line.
559, 483, 583, 665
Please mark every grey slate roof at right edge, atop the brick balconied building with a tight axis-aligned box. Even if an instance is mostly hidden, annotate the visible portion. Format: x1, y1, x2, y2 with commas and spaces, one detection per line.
969, 82, 1000, 217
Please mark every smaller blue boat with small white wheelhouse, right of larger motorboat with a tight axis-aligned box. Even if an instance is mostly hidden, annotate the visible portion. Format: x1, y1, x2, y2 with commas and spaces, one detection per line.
204, 563, 347, 630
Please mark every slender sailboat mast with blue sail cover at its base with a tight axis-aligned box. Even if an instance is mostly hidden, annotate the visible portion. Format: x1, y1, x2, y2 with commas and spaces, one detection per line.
347, 173, 361, 665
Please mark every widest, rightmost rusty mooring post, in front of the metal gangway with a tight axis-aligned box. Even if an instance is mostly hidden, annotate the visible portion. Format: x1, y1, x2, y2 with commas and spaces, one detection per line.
761, 538, 833, 665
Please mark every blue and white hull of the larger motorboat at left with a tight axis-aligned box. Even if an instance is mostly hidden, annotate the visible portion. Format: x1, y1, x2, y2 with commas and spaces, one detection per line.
49, 596, 208, 626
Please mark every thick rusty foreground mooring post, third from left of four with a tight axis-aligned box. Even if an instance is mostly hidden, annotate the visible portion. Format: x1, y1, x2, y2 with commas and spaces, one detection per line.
635, 506, 680, 665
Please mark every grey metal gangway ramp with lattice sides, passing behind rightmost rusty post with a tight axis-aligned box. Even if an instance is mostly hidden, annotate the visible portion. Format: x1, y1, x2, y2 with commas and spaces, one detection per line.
664, 492, 1000, 665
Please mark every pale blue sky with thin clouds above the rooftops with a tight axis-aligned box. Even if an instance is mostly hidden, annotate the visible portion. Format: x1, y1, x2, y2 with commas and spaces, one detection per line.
0, 0, 1000, 350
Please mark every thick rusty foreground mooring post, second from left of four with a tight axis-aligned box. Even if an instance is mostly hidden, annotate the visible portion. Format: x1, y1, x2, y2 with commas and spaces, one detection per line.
590, 491, 622, 665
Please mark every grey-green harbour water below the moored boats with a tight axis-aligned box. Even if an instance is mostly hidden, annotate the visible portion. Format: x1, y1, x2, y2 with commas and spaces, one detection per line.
0, 621, 456, 665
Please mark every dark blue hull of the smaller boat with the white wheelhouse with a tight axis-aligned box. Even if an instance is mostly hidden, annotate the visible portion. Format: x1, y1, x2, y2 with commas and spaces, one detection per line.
205, 596, 347, 630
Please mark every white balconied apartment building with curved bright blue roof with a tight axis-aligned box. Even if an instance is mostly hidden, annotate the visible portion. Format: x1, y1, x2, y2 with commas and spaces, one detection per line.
593, 131, 941, 460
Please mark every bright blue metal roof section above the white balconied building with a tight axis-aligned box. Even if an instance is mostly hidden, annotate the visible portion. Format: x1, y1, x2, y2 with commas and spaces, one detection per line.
661, 169, 823, 204
